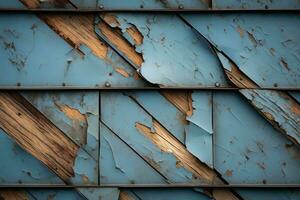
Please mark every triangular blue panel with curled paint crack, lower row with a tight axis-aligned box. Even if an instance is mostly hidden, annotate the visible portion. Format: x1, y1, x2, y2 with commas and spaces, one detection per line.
99, 122, 166, 184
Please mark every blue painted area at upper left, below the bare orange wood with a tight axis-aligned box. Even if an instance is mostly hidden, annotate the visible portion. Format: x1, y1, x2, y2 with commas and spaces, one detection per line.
0, 14, 147, 88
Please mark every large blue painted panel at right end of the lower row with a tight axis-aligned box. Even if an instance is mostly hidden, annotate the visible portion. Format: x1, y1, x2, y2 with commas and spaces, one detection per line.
214, 92, 300, 184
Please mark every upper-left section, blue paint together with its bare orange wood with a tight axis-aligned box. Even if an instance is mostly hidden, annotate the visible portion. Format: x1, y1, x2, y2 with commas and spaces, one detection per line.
0, 14, 149, 88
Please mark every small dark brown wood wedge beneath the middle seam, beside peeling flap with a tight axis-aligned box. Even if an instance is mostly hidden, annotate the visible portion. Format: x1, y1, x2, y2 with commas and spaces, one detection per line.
161, 91, 193, 116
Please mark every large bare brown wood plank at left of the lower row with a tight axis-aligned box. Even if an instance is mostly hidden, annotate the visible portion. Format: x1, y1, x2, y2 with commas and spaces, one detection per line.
0, 92, 78, 182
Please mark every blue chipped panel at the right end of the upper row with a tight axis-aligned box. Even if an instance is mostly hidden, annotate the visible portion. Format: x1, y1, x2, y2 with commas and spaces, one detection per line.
184, 13, 300, 88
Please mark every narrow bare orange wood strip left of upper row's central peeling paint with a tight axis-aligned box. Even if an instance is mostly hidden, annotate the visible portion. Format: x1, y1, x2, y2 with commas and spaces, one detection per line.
98, 22, 144, 67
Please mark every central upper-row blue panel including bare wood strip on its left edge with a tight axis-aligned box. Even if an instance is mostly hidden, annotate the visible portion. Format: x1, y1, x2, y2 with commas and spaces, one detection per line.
95, 13, 227, 87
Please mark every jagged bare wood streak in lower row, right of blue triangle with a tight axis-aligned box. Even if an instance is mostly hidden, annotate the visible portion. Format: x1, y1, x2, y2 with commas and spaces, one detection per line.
135, 120, 218, 183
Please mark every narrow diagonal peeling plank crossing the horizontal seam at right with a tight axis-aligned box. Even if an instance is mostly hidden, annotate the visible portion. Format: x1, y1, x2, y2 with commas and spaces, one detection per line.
217, 51, 300, 145
